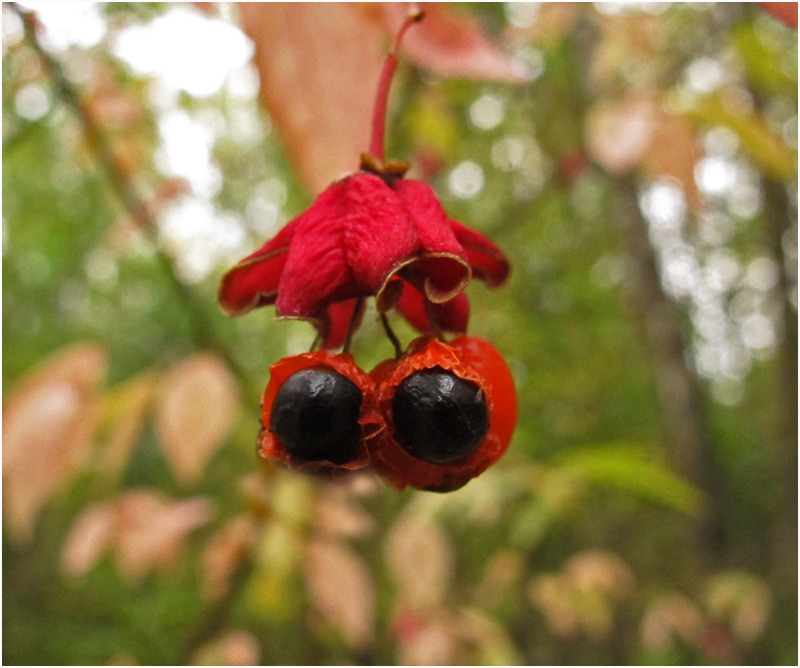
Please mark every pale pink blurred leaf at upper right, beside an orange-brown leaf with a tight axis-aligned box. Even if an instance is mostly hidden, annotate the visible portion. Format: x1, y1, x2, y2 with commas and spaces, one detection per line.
585, 93, 659, 175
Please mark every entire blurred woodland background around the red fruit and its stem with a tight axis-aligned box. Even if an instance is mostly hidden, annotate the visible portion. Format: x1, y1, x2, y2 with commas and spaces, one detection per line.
2, 2, 798, 665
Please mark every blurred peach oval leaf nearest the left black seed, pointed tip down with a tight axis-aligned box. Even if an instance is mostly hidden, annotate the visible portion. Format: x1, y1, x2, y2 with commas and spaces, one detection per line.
156, 353, 239, 483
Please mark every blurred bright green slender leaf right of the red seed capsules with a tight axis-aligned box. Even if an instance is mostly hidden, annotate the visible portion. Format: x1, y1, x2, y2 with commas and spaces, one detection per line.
553, 443, 702, 516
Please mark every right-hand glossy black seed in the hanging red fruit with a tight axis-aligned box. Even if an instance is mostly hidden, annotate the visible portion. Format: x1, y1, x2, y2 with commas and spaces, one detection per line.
392, 367, 489, 464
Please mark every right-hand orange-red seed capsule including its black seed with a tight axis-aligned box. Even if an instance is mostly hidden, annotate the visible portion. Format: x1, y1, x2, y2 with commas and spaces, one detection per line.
370, 336, 517, 492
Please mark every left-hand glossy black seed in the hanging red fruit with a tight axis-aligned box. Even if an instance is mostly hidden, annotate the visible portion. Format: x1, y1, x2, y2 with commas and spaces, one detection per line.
269, 366, 362, 464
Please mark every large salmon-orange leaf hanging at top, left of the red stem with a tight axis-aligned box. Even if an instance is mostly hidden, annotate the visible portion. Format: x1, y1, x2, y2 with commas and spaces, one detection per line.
239, 2, 383, 193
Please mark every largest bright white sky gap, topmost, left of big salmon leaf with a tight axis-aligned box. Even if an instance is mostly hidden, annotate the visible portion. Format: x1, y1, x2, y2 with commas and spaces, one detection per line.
112, 7, 253, 97
